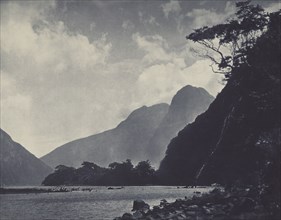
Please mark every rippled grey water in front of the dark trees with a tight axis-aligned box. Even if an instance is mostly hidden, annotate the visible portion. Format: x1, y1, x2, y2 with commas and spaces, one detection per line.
0, 186, 209, 220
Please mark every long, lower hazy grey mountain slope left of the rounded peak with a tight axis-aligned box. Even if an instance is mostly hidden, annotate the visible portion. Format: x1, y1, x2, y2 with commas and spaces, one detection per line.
42, 104, 169, 167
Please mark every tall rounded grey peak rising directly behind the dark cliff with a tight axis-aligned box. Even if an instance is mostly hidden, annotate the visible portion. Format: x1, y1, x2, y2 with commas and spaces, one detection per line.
147, 85, 214, 166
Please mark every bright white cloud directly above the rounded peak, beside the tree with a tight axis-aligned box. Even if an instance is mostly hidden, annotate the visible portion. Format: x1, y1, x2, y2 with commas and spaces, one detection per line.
133, 33, 223, 105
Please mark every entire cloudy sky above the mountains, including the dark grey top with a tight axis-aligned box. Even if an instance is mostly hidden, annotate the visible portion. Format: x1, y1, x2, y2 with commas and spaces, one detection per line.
1, 0, 278, 156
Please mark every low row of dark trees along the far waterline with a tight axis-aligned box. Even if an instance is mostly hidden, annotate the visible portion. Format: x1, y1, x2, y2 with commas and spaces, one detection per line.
42, 159, 155, 186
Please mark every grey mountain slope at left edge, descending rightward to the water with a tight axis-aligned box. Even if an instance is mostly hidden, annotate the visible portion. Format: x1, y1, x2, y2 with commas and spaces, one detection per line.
0, 129, 52, 186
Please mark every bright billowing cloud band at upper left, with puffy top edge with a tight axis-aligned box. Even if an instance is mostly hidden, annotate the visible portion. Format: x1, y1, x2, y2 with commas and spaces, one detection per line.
1, 15, 111, 72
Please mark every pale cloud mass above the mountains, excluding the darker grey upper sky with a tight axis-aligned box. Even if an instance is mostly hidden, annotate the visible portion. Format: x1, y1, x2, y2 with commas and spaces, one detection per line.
1, 1, 223, 156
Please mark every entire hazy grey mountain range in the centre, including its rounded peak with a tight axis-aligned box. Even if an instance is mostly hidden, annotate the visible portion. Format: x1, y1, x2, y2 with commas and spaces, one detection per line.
42, 86, 213, 167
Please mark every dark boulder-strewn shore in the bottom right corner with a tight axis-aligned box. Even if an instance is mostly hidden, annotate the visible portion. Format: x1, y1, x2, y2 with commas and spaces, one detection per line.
114, 187, 280, 220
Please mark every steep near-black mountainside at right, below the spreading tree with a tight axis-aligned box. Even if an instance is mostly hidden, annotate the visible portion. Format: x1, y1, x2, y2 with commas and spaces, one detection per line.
159, 15, 280, 189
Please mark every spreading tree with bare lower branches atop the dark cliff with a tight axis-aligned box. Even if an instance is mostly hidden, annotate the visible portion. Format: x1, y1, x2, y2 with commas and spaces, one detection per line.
186, 0, 269, 78
